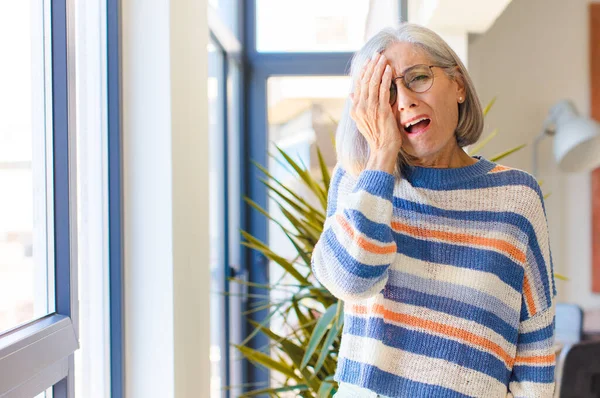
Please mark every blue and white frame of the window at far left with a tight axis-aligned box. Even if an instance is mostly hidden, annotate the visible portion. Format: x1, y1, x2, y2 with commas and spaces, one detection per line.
0, 0, 79, 398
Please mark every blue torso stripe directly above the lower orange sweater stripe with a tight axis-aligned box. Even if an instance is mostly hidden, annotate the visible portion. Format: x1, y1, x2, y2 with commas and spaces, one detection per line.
383, 285, 519, 342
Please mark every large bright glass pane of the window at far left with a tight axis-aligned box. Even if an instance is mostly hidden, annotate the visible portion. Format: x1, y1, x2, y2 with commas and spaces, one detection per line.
0, 1, 54, 333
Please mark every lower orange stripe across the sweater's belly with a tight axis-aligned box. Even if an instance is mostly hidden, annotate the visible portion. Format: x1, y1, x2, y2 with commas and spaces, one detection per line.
351, 304, 514, 367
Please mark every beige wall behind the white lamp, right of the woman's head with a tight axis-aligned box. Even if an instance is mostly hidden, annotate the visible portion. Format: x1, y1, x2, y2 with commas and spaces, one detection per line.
469, 0, 600, 309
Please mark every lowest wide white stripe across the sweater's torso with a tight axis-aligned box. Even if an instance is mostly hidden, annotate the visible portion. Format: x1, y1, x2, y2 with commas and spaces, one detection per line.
340, 334, 506, 398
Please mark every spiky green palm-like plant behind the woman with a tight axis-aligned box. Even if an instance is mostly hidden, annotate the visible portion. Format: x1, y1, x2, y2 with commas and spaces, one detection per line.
232, 101, 566, 397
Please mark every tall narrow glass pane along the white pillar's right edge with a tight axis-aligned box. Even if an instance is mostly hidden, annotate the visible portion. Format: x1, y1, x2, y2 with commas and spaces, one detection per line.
208, 43, 225, 398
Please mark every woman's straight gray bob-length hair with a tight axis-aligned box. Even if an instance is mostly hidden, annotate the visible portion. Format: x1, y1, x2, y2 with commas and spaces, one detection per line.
336, 23, 483, 177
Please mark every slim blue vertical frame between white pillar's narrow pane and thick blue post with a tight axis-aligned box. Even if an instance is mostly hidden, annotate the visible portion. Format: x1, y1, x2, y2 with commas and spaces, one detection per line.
208, 0, 246, 398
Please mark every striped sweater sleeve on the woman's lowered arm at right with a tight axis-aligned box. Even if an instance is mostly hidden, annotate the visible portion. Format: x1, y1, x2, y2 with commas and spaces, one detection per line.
509, 181, 556, 398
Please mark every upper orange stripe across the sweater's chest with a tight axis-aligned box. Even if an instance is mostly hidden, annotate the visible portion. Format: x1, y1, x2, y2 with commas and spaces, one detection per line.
392, 221, 526, 263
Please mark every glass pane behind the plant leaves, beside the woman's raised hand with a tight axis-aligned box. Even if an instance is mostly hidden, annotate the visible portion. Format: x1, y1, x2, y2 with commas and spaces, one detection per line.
267, 77, 350, 386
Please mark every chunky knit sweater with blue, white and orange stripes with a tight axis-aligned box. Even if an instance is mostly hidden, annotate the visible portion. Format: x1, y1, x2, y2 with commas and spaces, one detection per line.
312, 156, 556, 398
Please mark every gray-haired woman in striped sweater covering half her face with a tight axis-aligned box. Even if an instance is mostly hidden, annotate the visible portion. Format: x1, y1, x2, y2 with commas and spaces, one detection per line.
312, 24, 556, 398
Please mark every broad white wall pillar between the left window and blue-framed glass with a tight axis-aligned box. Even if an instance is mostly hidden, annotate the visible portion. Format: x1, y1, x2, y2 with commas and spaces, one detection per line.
122, 0, 210, 398
